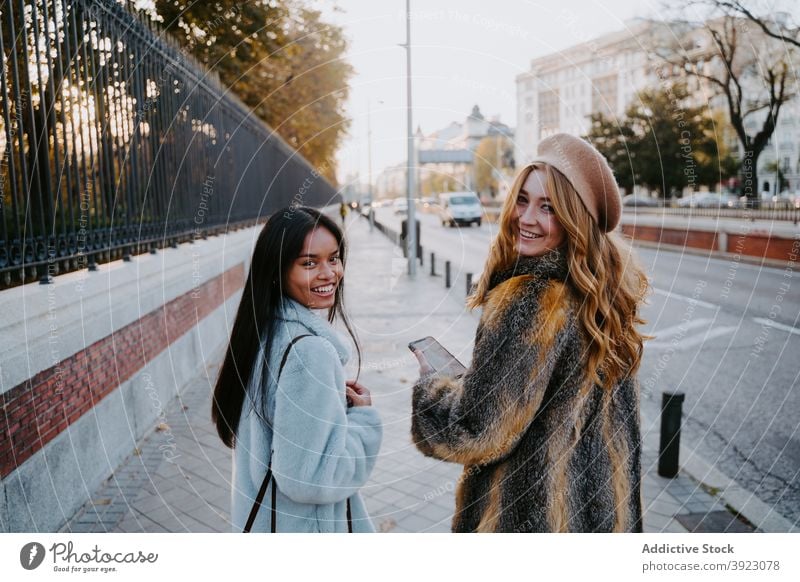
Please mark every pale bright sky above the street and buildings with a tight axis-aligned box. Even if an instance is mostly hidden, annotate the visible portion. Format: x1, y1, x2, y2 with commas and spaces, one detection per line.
329, 0, 658, 182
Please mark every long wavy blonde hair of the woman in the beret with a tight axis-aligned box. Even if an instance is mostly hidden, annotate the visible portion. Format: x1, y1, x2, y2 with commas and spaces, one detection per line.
467, 163, 649, 388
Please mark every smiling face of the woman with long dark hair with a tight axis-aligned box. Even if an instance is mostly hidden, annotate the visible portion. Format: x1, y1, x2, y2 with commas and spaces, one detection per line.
285, 226, 344, 309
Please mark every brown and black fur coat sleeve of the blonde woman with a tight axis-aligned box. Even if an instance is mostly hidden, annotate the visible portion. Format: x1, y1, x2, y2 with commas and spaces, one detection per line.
411, 276, 574, 465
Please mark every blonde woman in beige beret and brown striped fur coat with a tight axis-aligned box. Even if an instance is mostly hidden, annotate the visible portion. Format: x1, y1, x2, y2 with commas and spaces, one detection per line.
412, 134, 648, 532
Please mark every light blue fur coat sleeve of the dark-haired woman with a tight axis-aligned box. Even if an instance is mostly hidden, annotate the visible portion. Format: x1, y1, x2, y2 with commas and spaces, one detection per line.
272, 336, 382, 504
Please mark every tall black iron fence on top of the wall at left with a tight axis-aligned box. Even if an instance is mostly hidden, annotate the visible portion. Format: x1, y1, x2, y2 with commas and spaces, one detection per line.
0, 0, 337, 287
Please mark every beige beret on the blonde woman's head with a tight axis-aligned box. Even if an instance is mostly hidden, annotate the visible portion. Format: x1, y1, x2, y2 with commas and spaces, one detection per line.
532, 133, 622, 232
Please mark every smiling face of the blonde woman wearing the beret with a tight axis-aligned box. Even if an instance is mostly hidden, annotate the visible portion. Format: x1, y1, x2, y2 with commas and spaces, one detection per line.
514, 170, 566, 257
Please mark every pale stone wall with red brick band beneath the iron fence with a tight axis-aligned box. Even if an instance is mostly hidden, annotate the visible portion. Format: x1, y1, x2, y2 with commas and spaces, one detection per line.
0, 228, 260, 532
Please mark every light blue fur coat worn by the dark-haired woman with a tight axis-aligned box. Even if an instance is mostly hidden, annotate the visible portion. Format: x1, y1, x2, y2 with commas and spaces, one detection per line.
231, 298, 383, 533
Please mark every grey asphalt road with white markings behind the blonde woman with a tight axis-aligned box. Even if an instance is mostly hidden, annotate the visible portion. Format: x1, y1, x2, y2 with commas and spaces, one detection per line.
376, 208, 800, 522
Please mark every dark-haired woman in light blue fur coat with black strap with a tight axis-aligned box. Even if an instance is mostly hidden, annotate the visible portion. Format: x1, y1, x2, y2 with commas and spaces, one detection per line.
211, 207, 382, 532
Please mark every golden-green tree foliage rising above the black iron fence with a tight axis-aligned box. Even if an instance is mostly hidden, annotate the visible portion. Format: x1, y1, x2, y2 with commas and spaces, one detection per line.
150, 0, 353, 183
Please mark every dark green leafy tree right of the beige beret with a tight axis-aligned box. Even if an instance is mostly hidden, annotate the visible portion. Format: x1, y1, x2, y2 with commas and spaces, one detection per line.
587, 84, 736, 197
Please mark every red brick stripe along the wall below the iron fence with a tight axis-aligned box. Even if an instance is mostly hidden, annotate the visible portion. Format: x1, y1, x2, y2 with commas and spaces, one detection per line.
0, 263, 244, 478
